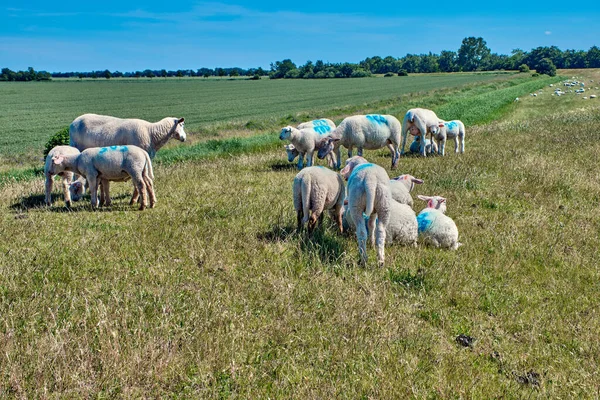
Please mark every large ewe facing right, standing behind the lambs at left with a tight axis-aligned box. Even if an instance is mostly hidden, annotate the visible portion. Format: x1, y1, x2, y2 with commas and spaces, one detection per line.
69, 114, 186, 158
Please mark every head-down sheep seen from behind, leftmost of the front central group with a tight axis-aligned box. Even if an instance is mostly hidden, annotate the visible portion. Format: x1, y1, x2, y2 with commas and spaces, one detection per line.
293, 166, 345, 233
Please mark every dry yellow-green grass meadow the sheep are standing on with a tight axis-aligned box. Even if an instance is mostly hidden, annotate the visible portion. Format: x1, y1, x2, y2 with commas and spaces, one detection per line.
0, 70, 600, 399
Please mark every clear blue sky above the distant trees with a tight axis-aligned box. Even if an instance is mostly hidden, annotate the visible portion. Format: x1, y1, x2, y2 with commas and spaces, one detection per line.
0, 0, 600, 72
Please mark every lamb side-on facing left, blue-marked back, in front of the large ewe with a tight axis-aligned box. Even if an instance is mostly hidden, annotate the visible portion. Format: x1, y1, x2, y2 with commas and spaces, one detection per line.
49, 146, 156, 210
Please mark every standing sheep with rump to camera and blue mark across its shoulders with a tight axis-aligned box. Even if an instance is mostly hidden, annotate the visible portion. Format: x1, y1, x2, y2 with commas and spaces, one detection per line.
341, 156, 392, 266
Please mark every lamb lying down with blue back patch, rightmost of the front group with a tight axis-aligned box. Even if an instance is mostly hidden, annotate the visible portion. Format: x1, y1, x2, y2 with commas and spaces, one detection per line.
417, 195, 462, 250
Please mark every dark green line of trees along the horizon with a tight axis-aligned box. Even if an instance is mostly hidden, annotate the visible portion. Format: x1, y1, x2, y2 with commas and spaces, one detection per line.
0, 37, 600, 81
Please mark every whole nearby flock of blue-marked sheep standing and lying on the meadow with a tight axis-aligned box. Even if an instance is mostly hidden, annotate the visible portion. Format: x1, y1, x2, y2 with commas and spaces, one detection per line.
44, 108, 465, 264
